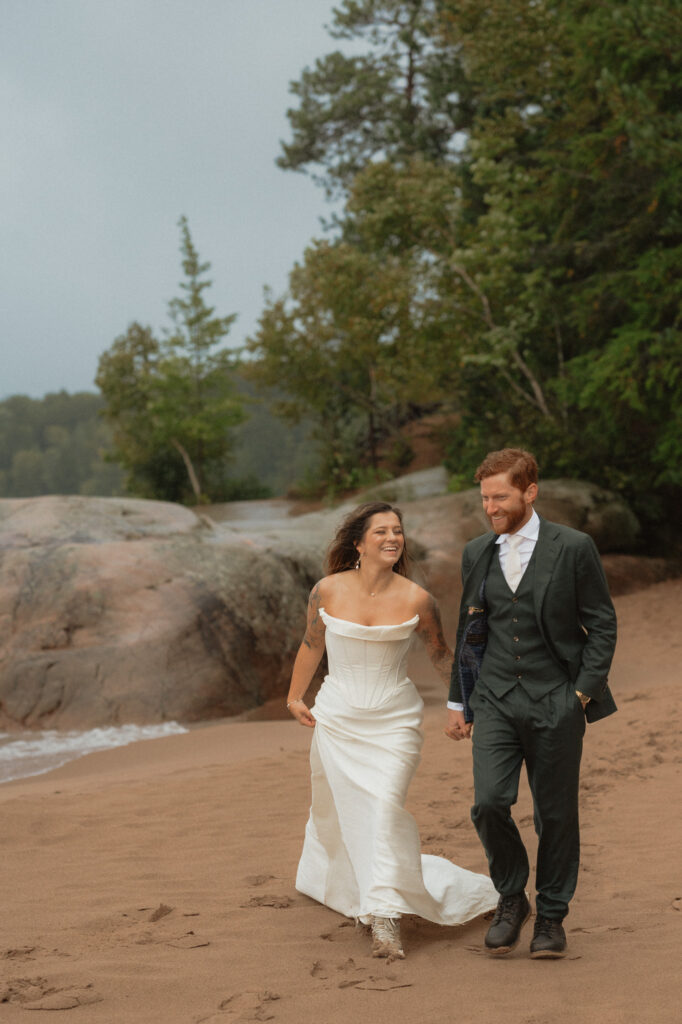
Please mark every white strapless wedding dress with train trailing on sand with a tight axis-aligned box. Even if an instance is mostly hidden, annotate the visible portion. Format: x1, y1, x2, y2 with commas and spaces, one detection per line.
296, 608, 498, 925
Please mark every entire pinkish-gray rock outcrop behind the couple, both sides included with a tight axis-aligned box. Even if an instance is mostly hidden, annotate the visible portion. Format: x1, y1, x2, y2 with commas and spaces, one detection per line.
0, 468, 657, 728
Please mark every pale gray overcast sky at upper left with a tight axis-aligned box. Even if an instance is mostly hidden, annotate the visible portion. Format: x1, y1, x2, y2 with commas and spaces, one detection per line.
0, 0, 346, 398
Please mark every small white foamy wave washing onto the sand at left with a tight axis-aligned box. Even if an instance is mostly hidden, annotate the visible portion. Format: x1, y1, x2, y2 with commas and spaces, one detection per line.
0, 722, 188, 782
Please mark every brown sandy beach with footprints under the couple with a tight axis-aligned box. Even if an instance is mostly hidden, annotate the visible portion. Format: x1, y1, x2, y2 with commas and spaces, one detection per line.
0, 580, 682, 1024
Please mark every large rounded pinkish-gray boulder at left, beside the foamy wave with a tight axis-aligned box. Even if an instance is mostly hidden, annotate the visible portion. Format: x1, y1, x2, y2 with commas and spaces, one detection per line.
0, 497, 318, 728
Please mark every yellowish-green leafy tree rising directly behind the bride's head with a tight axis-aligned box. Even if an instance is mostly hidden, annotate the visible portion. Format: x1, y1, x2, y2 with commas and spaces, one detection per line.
245, 220, 448, 489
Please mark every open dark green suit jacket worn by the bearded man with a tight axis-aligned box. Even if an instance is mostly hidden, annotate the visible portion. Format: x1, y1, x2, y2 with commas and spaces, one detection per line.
450, 518, 616, 722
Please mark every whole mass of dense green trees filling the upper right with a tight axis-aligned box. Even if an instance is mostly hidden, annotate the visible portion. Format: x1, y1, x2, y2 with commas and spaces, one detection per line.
250, 0, 682, 540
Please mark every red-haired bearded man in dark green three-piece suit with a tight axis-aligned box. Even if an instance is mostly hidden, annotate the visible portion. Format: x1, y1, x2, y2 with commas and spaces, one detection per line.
446, 449, 615, 958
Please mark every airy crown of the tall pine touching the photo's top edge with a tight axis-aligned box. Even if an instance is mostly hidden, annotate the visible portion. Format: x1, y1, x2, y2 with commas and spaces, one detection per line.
278, 0, 472, 193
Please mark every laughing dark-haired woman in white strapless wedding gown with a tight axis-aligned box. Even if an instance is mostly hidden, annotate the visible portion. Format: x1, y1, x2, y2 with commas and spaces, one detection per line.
287, 502, 498, 958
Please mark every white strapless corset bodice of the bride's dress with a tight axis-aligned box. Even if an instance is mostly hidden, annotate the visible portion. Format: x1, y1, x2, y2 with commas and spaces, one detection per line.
319, 608, 419, 708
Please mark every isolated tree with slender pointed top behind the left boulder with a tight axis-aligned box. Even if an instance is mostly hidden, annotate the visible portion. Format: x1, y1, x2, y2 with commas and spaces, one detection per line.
95, 217, 245, 501
